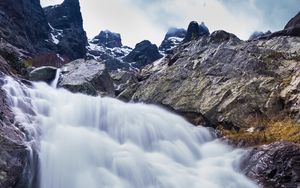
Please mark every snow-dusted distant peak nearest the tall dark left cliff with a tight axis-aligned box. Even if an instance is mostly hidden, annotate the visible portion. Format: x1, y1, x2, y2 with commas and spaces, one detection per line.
91, 30, 123, 48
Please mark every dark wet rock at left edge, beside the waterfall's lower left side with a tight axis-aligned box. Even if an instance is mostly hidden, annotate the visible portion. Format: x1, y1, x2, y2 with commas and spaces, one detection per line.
0, 72, 30, 188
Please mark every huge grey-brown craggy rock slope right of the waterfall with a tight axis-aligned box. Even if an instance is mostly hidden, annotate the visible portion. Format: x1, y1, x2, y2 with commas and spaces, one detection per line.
132, 31, 300, 128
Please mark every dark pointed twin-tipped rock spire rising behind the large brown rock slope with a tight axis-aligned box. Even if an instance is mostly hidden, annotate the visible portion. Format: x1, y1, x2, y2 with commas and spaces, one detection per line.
183, 21, 209, 42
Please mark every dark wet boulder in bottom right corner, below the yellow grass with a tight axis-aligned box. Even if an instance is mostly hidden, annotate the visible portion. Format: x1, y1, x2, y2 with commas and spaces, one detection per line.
241, 142, 300, 188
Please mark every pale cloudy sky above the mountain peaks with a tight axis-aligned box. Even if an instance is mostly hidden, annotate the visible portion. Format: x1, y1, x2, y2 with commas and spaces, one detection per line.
41, 0, 300, 47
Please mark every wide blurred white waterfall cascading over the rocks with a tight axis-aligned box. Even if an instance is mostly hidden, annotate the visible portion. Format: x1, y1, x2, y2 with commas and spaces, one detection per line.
4, 77, 257, 188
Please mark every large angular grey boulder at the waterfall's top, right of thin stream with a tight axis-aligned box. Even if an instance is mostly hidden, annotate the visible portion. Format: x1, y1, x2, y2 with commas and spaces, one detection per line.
58, 59, 114, 96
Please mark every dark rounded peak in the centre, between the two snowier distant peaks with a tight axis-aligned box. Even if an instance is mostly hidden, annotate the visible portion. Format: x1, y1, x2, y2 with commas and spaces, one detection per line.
123, 40, 162, 69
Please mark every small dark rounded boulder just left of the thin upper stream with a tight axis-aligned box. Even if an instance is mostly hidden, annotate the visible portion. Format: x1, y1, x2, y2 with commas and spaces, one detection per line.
29, 66, 57, 84
